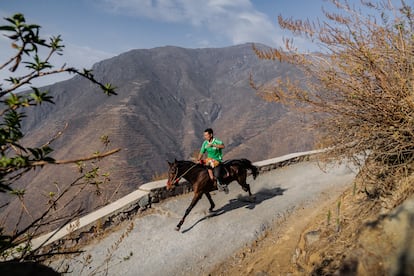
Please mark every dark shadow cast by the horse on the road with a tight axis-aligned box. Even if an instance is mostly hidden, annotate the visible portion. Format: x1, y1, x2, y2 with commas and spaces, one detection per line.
181, 187, 287, 233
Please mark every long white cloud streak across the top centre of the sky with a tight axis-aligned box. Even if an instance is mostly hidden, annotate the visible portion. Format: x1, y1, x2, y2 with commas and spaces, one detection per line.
100, 0, 281, 47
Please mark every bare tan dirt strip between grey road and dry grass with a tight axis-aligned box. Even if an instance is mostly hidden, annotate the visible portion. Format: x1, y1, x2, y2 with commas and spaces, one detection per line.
210, 184, 343, 276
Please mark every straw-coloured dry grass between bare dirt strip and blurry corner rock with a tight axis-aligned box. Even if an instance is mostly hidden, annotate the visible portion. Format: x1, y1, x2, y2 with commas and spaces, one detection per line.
295, 166, 414, 275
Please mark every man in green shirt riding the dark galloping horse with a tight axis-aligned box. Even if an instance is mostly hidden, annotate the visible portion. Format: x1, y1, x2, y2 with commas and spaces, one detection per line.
197, 128, 229, 194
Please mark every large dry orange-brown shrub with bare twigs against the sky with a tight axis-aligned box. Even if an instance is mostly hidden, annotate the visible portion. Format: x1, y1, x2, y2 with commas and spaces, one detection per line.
251, 0, 414, 199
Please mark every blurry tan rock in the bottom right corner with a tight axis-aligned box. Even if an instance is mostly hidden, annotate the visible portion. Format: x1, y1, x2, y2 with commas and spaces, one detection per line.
341, 198, 414, 275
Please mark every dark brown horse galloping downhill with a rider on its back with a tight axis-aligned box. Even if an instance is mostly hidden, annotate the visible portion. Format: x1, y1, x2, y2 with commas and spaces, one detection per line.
167, 159, 259, 231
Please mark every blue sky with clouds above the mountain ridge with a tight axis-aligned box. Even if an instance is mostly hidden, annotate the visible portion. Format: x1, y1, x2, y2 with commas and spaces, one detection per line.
0, 0, 392, 86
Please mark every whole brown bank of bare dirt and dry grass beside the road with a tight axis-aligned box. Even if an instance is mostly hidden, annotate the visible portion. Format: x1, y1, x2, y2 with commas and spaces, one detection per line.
211, 167, 414, 276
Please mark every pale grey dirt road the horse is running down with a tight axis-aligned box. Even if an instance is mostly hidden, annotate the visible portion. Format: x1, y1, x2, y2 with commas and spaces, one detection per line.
51, 162, 356, 276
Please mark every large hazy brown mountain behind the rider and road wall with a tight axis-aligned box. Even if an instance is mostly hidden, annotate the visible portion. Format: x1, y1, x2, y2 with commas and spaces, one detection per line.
4, 44, 313, 233
